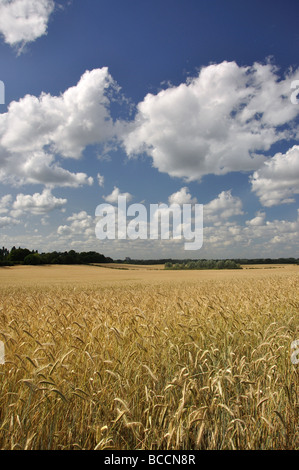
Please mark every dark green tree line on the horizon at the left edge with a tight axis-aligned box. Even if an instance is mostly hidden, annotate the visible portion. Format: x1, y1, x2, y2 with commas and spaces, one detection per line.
0, 246, 113, 266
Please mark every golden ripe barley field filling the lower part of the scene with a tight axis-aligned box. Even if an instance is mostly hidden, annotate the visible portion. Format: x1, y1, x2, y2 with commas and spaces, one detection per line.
0, 266, 299, 450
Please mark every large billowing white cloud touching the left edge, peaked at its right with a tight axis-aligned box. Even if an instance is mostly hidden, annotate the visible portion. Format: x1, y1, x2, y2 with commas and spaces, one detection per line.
0, 67, 118, 187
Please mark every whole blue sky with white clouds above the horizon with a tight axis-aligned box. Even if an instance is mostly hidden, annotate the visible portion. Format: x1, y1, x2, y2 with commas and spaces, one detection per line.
0, 0, 299, 259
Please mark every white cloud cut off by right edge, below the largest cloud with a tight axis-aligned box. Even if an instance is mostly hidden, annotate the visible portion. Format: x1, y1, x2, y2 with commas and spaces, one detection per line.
251, 145, 299, 207
